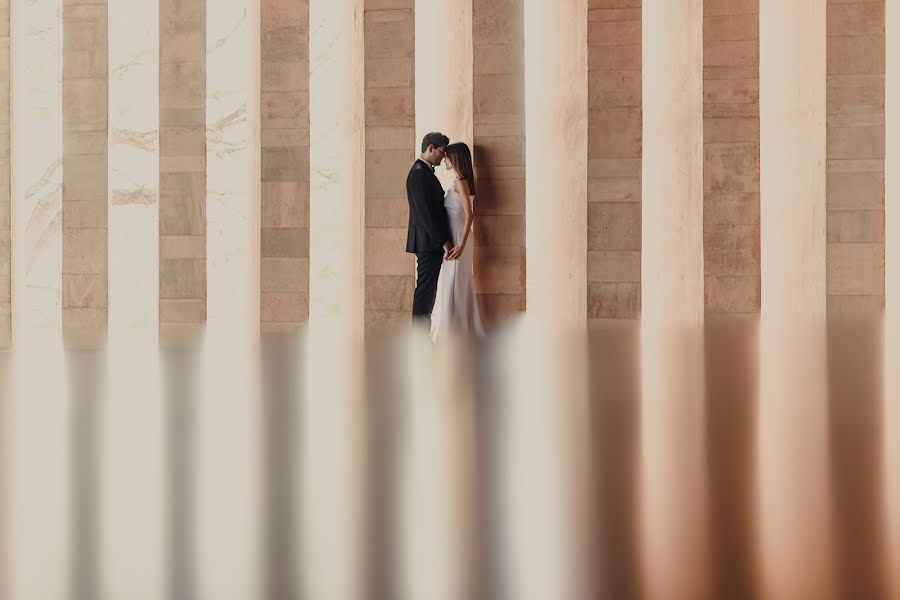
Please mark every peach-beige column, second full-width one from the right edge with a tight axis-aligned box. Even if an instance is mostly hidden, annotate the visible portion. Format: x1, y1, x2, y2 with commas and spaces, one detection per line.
640, 0, 707, 599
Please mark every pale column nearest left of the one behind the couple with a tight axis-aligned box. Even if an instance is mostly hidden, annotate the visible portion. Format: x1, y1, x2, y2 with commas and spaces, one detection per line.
301, 0, 370, 600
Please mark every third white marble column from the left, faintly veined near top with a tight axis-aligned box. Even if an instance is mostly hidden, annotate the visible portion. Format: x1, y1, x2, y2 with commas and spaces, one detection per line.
194, 0, 263, 600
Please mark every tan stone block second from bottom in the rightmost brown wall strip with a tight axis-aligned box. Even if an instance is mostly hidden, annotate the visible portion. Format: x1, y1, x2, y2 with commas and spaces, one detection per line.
825, 244, 884, 295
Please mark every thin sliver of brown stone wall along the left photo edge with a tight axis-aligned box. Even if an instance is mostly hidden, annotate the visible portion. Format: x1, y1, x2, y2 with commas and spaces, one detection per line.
0, 0, 12, 348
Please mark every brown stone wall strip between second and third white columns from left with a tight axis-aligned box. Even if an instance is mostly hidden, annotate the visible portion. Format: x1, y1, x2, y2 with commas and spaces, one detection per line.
159, 0, 206, 336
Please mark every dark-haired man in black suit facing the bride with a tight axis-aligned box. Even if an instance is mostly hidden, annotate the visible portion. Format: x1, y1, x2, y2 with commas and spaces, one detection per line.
406, 132, 453, 323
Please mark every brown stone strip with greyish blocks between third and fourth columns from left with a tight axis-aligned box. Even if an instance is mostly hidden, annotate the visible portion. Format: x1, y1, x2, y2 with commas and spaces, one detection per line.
260, 0, 309, 330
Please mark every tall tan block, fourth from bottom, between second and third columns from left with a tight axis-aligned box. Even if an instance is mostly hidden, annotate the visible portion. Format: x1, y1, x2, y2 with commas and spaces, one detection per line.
159, 173, 206, 235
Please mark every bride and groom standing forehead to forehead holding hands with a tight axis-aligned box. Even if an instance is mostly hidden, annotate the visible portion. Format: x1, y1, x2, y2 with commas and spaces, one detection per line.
406, 133, 484, 337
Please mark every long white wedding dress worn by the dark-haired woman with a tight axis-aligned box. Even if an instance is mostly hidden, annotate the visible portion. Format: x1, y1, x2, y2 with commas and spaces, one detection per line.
432, 187, 484, 339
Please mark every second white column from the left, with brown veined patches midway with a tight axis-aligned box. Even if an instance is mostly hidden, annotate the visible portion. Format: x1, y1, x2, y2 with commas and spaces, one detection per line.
98, 0, 167, 600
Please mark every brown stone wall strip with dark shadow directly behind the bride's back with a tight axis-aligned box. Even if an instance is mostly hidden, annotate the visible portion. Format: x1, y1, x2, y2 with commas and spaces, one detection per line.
472, 0, 525, 325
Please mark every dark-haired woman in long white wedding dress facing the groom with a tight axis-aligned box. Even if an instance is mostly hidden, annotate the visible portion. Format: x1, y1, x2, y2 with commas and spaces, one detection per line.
435, 142, 484, 338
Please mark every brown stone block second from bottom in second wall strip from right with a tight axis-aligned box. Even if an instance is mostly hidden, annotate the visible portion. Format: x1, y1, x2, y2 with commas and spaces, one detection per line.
703, 224, 760, 276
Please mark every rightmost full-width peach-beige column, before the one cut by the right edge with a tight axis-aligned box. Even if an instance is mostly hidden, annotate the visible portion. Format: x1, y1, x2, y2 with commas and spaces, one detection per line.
757, 0, 833, 600
